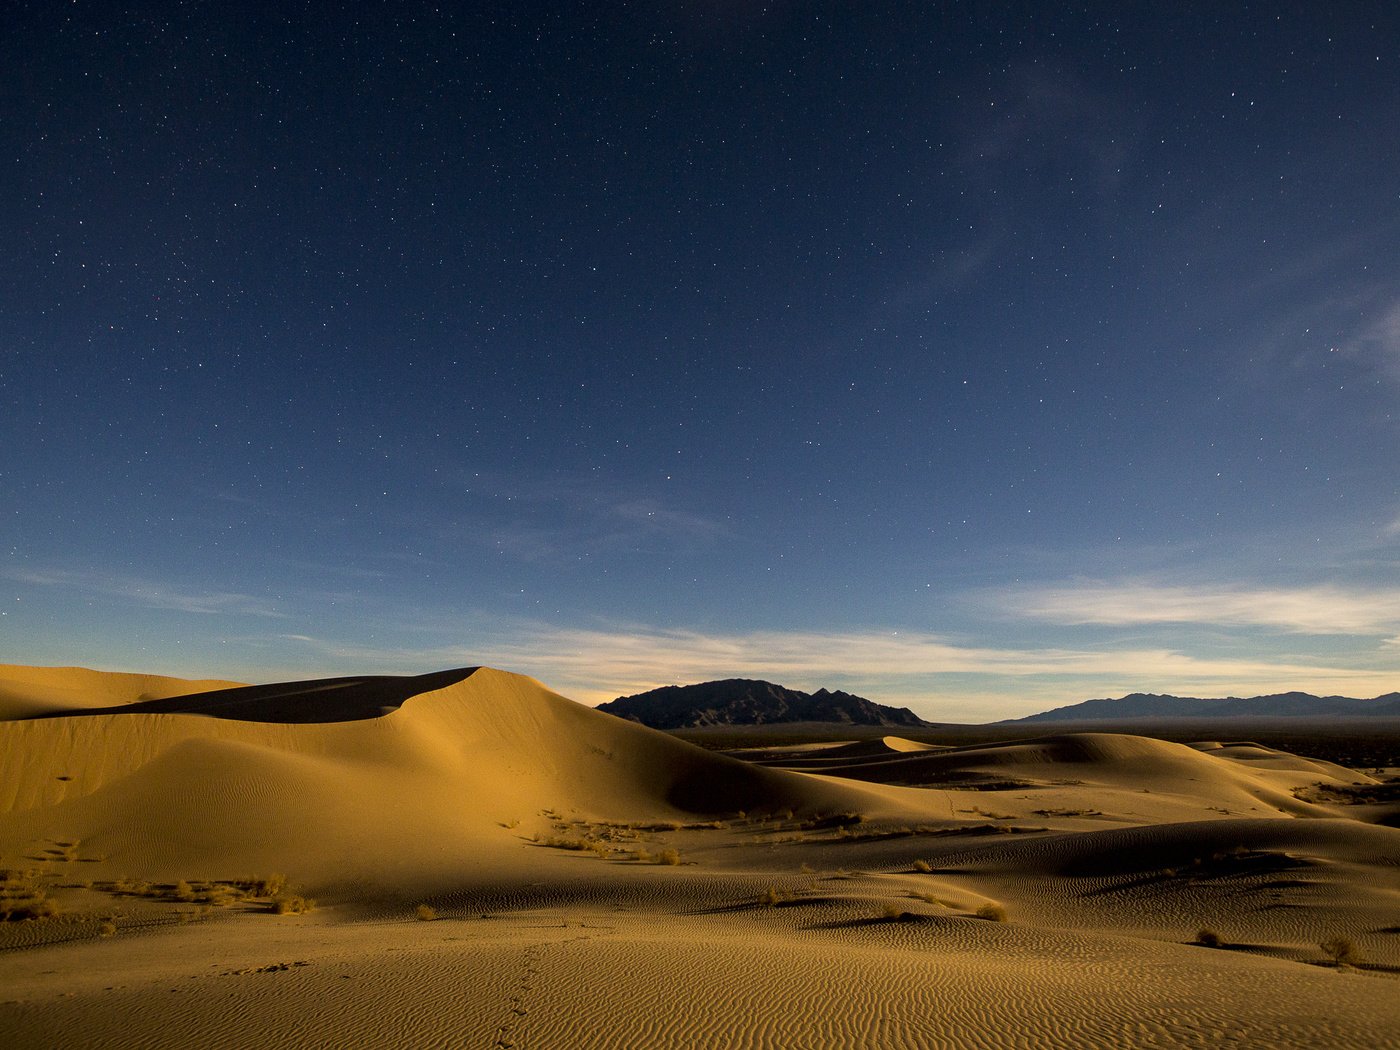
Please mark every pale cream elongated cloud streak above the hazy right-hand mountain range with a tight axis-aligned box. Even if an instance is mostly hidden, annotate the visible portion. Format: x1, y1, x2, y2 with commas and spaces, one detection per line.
994, 581, 1400, 636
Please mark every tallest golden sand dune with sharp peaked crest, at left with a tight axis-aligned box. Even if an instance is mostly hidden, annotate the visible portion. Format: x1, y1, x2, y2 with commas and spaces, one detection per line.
0, 668, 879, 883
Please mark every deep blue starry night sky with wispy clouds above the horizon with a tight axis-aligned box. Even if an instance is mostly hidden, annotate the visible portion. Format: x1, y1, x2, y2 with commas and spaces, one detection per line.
0, 0, 1400, 721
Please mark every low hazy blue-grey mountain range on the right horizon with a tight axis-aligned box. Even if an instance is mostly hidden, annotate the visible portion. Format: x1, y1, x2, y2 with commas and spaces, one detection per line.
1002, 692, 1400, 722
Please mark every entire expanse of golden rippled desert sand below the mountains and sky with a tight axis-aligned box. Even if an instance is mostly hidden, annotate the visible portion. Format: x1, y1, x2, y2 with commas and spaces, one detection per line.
0, 665, 1400, 1050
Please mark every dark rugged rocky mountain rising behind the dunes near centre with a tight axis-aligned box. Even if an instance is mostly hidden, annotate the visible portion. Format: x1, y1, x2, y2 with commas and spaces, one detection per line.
598, 678, 928, 729
